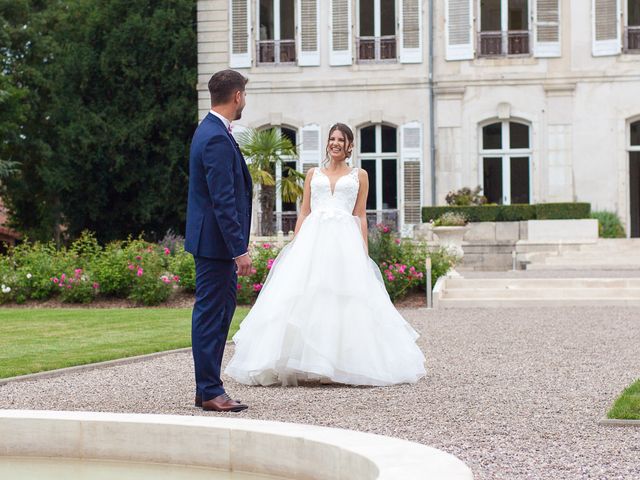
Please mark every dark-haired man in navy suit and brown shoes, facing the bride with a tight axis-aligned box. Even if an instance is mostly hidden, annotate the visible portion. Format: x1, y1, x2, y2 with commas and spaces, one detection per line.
185, 70, 253, 412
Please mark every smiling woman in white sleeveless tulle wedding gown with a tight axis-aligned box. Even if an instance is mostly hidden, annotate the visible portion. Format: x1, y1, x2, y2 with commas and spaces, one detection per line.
225, 123, 425, 386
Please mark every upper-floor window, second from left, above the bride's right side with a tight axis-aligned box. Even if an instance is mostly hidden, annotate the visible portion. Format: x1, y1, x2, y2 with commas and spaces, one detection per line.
357, 0, 397, 63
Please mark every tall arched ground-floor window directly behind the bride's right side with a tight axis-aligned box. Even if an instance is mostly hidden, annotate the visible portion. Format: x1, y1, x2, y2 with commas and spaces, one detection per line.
359, 125, 399, 229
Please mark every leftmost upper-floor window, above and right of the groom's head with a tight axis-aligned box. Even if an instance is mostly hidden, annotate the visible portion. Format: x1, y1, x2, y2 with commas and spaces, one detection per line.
257, 0, 296, 64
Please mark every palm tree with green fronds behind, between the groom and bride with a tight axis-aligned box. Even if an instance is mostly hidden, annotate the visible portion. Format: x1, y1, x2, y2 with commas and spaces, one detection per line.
240, 128, 304, 235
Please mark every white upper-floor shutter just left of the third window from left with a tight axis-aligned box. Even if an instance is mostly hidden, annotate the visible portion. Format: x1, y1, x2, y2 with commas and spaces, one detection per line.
444, 0, 473, 60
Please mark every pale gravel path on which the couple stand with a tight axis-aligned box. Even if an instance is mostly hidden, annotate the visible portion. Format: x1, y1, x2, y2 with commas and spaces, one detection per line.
0, 308, 640, 480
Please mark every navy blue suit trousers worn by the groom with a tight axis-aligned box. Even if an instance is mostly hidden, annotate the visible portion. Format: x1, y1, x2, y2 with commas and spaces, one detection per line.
191, 257, 237, 401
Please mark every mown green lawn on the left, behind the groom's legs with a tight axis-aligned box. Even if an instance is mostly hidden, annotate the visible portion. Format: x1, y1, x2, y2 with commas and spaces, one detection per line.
0, 307, 249, 378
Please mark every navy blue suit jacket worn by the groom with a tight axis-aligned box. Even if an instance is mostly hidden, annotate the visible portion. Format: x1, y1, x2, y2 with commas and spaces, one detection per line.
184, 113, 253, 260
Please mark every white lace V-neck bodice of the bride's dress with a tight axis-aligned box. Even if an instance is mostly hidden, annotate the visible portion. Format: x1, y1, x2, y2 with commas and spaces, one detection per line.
311, 167, 360, 215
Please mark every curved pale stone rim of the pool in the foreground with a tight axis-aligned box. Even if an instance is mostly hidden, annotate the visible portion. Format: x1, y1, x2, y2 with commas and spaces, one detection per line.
0, 410, 473, 480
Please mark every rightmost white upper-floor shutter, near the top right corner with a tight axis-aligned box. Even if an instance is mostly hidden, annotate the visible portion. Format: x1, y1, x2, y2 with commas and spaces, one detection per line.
591, 0, 622, 57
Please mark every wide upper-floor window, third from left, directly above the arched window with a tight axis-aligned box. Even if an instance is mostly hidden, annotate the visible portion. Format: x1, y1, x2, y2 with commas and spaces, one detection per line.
478, 0, 530, 57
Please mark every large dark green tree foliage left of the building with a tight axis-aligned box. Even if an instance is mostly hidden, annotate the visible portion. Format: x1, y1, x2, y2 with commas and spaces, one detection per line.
0, 0, 197, 241
